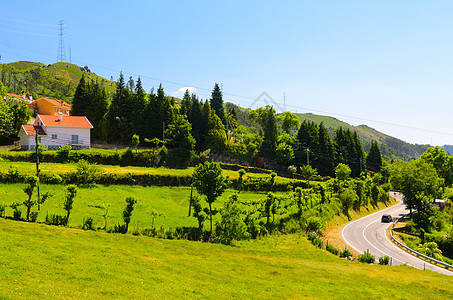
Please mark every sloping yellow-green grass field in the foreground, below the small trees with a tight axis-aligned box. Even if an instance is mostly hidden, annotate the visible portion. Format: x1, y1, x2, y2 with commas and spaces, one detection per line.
0, 219, 453, 299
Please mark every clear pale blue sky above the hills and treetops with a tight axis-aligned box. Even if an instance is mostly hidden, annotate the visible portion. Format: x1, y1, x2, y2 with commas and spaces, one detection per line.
0, 0, 453, 145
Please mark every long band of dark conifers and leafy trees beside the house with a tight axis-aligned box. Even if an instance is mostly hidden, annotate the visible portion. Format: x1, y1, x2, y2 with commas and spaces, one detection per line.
71, 74, 382, 177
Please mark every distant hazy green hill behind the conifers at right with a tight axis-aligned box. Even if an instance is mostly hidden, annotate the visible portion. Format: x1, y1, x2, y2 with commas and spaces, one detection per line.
296, 113, 430, 161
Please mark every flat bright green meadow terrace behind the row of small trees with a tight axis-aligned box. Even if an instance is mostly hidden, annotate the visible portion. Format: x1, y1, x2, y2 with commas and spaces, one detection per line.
0, 184, 281, 229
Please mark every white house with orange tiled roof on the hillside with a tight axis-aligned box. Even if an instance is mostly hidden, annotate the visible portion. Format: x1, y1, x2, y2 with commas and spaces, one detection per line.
19, 114, 93, 150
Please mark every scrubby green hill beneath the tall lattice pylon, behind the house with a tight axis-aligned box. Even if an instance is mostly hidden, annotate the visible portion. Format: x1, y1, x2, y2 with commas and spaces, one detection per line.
0, 61, 116, 103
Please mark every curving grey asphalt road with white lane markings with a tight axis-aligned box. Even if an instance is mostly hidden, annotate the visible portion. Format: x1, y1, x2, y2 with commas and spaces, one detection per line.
341, 193, 453, 275
